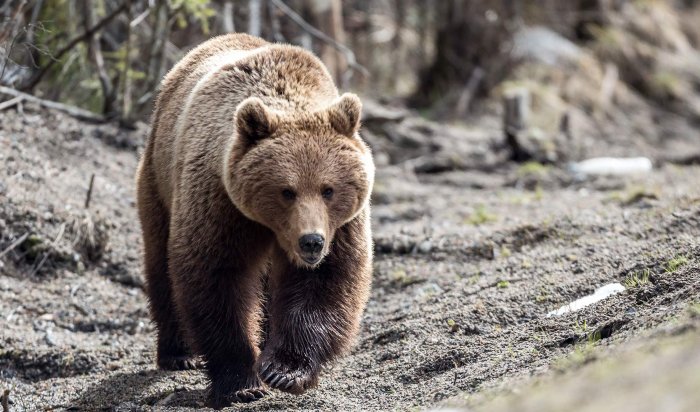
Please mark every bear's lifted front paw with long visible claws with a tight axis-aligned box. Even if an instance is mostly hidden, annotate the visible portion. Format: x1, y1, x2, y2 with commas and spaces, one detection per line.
260, 356, 318, 395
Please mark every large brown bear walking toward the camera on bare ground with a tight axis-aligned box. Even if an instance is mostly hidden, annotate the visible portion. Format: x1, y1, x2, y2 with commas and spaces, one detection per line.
137, 34, 374, 407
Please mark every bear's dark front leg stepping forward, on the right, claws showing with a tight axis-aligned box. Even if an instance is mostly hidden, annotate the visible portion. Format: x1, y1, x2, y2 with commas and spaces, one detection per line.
259, 211, 372, 394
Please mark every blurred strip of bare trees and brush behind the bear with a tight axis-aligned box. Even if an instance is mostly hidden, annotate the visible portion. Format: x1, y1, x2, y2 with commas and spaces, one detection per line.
0, 0, 700, 128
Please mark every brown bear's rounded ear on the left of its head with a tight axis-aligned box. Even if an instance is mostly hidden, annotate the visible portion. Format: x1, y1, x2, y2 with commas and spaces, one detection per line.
235, 97, 277, 146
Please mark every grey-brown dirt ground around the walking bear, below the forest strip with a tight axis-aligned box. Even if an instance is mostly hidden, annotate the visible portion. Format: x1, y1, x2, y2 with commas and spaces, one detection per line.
0, 107, 700, 412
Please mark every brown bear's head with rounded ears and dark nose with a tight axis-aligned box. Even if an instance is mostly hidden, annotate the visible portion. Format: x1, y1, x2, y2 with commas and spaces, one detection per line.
224, 93, 374, 268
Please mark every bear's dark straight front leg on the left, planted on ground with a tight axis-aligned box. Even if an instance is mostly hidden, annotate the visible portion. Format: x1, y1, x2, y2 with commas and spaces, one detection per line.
168, 196, 268, 408
